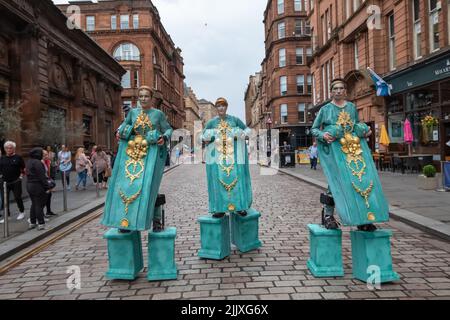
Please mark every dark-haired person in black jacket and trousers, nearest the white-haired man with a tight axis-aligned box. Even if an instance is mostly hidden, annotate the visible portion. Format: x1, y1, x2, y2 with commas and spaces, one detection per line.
26, 148, 53, 230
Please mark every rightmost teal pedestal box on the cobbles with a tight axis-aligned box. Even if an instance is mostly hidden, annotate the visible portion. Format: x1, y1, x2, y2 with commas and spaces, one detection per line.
350, 229, 400, 283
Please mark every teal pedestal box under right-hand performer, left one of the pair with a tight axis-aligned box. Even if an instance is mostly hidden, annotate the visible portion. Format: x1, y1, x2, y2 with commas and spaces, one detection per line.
307, 224, 344, 277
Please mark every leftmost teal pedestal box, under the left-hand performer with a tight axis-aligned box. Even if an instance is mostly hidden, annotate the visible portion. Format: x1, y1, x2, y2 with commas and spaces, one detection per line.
103, 228, 144, 280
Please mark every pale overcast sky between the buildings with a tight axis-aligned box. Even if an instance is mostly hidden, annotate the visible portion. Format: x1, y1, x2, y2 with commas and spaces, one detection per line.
53, 0, 267, 120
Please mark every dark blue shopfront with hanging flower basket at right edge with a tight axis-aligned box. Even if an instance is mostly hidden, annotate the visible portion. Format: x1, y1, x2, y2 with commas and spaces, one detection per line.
385, 51, 450, 166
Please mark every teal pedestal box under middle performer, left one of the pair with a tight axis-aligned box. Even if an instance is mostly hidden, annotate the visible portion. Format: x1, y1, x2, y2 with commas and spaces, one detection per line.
198, 215, 231, 260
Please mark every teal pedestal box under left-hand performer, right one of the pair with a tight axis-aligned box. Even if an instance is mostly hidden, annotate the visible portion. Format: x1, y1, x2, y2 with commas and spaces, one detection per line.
147, 228, 178, 281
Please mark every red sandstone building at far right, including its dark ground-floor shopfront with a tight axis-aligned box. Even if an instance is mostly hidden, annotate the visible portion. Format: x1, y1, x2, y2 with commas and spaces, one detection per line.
308, 0, 450, 161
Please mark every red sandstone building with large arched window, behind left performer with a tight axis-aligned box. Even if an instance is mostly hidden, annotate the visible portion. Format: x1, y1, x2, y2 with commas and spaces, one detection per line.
59, 0, 185, 129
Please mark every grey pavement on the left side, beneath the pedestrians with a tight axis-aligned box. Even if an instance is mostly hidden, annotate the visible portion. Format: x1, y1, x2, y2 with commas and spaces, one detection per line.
0, 165, 177, 262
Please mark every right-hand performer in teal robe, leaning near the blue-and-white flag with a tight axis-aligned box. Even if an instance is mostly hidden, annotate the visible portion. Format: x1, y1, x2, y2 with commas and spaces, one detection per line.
311, 79, 389, 231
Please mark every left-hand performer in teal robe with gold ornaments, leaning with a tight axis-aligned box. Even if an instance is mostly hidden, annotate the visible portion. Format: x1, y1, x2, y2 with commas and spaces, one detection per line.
102, 86, 173, 232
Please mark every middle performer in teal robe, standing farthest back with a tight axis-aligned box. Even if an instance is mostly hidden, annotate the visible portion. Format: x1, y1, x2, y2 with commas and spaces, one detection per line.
202, 98, 253, 218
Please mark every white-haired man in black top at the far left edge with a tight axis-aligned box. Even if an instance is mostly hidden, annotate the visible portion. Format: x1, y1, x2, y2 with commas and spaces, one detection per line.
0, 141, 25, 223
